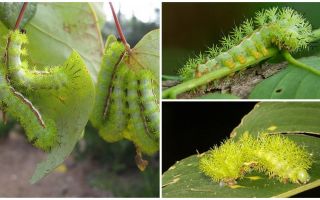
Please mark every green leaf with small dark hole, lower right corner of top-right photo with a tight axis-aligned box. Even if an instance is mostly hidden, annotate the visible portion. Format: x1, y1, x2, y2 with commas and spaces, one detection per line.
249, 56, 320, 99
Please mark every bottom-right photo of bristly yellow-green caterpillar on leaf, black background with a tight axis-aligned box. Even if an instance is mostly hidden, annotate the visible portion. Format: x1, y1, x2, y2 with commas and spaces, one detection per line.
162, 101, 320, 198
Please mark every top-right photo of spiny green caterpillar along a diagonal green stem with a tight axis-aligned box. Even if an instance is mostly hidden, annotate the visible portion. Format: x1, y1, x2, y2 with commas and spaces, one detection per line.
162, 2, 320, 99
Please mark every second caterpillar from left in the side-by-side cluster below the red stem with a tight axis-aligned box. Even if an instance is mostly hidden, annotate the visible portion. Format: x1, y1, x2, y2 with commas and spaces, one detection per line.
99, 63, 128, 142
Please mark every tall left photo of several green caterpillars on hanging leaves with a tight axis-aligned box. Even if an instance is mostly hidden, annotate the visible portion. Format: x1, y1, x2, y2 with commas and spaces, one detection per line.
0, 0, 161, 198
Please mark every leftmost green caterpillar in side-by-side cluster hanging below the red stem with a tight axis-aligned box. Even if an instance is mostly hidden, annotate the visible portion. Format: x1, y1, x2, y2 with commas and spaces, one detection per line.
90, 35, 125, 128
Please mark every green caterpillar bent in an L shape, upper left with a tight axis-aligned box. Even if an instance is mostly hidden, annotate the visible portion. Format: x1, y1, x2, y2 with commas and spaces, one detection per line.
7, 31, 80, 90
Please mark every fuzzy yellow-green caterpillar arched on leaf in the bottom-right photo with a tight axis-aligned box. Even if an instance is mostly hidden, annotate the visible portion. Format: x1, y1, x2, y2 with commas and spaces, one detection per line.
199, 133, 312, 185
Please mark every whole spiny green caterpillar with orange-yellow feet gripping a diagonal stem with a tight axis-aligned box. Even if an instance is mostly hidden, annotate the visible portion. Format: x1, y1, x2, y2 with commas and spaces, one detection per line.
180, 8, 312, 80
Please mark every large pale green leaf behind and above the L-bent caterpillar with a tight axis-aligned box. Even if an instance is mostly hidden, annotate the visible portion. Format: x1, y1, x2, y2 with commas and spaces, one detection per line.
26, 3, 104, 81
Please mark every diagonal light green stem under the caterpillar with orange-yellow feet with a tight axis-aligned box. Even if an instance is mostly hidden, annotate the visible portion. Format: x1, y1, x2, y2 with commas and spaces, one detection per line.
162, 48, 279, 98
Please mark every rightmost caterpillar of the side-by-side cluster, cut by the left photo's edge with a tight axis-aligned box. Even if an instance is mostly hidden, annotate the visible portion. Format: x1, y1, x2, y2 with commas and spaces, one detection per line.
138, 69, 160, 140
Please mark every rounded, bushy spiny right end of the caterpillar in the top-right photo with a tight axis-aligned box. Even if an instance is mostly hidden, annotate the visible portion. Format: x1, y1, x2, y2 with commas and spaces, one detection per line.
256, 8, 312, 52
